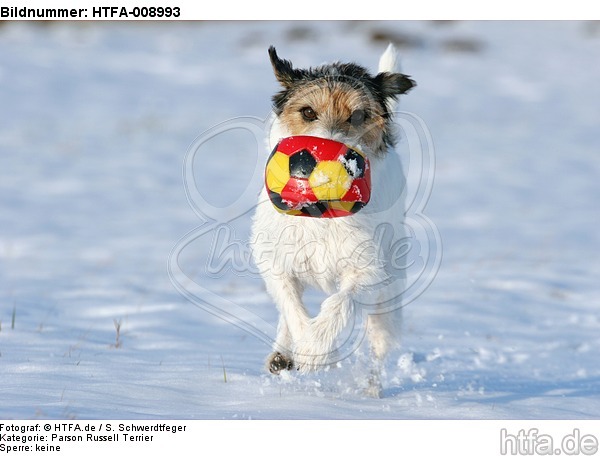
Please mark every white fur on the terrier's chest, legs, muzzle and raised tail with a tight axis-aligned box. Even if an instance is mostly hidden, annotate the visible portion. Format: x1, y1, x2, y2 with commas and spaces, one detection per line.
251, 47, 405, 382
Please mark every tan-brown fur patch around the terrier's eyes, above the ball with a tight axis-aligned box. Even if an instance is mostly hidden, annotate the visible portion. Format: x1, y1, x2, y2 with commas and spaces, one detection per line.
279, 79, 386, 153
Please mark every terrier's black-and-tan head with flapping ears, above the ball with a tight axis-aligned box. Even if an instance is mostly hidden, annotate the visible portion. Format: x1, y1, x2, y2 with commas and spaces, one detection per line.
269, 46, 415, 155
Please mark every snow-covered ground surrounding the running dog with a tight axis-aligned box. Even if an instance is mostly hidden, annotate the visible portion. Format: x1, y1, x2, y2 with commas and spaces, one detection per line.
0, 21, 600, 419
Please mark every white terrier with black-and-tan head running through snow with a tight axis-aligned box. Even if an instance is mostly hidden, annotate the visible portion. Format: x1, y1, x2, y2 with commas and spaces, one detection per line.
250, 45, 416, 395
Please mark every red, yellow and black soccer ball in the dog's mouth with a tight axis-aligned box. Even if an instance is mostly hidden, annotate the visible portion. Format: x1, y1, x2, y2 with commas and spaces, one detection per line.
265, 136, 371, 217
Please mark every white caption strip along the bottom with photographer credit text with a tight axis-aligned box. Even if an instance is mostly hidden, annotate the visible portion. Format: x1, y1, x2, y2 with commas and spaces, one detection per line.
7, 420, 600, 456
